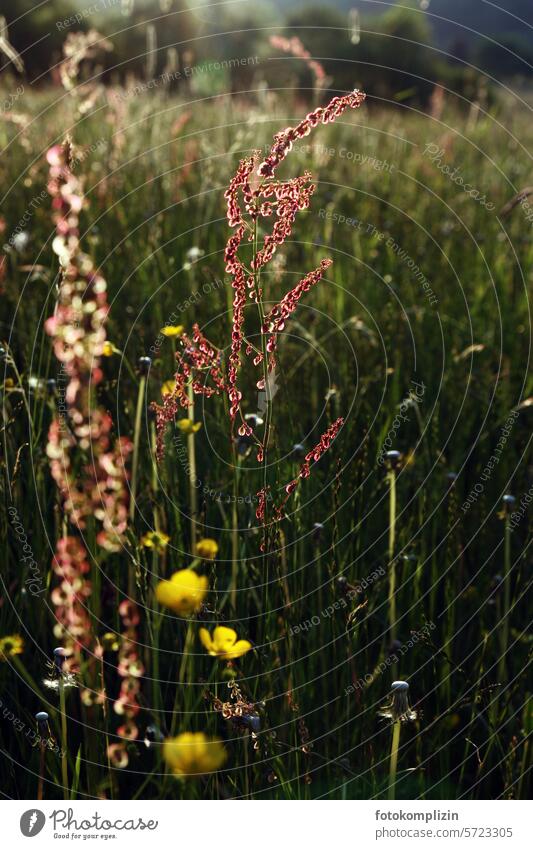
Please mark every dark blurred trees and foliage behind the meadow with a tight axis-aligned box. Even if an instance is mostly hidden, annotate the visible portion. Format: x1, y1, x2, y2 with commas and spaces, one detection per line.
0, 0, 533, 104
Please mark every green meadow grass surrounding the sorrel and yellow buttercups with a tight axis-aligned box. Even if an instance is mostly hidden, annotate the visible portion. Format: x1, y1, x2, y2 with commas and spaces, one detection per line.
0, 83, 533, 799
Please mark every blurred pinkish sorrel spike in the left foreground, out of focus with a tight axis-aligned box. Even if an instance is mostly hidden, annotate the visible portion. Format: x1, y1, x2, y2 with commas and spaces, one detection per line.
45, 141, 133, 654
